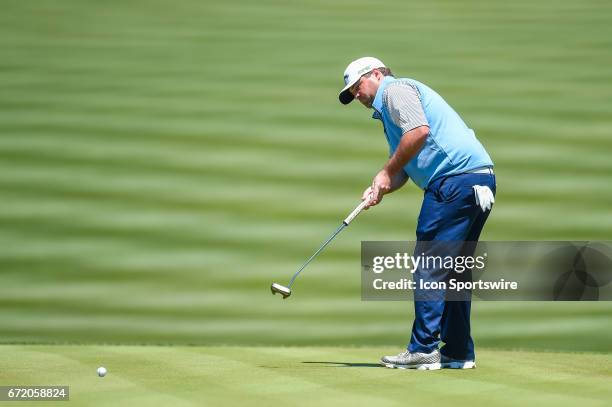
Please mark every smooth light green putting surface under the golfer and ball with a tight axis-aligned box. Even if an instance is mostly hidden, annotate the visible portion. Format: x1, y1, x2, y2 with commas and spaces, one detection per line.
0, 345, 612, 406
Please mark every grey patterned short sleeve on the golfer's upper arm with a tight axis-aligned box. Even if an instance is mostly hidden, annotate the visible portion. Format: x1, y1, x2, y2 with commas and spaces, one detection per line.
385, 84, 429, 134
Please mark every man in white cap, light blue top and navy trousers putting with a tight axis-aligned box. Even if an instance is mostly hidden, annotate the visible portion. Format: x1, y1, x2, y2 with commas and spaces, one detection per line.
339, 57, 496, 369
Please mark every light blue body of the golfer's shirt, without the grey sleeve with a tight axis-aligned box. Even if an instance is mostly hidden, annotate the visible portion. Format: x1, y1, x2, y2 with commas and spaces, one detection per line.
372, 76, 493, 189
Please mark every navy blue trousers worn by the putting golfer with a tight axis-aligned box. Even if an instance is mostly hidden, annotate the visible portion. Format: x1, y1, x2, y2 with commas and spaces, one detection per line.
408, 174, 496, 359
